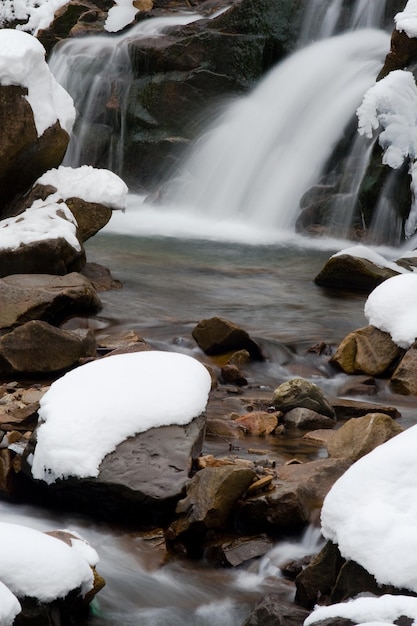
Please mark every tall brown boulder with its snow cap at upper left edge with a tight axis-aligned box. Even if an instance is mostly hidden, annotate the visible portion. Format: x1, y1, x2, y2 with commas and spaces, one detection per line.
0, 28, 75, 216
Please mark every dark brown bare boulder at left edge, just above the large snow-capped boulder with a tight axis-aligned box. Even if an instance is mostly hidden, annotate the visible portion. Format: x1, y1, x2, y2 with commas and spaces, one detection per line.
0, 320, 96, 376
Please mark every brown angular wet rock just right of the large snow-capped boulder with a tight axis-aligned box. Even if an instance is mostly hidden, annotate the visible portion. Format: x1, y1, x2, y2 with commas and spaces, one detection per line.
168, 465, 256, 551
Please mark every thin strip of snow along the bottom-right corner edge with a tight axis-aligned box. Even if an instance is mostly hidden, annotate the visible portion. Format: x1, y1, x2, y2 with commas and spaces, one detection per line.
304, 594, 417, 626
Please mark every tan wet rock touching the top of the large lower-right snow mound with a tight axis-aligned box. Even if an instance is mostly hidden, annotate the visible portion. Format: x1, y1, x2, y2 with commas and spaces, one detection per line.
327, 413, 404, 461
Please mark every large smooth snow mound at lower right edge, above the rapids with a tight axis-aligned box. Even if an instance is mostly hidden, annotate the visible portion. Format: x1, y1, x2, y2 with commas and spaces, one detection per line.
321, 426, 417, 592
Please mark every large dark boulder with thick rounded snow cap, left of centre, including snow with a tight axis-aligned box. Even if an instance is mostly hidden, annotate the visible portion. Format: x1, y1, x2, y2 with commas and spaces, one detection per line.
20, 351, 211, 525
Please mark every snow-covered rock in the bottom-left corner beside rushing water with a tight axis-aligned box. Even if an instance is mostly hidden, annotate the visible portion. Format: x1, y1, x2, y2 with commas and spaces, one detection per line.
0, 522, 105, 626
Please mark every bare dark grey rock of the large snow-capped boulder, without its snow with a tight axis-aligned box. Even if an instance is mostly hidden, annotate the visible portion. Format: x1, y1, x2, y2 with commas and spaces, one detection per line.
17, 414, 205, 528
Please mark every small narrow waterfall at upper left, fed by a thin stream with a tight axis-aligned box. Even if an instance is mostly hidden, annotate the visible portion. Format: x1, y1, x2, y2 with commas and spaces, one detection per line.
49, 13, 201, 175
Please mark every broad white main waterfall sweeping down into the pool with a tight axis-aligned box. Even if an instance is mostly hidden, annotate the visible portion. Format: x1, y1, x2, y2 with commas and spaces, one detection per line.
169, 29, 389, 230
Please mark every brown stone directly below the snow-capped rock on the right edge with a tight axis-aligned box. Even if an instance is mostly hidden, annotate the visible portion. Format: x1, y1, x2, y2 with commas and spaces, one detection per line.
329, 326, 403, 376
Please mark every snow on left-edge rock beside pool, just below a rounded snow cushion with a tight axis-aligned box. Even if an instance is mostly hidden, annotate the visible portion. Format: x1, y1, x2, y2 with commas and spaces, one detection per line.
0, 205, 81, 251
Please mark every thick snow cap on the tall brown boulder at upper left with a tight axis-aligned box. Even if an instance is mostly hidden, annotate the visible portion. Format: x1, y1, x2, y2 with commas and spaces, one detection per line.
0, 28, 75, 137
